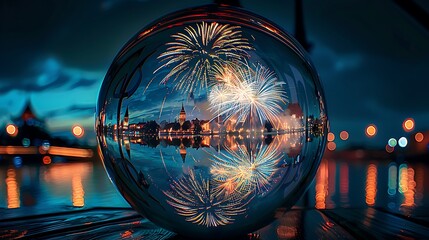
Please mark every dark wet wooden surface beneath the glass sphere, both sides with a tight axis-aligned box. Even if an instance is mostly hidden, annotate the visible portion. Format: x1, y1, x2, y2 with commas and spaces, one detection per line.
0, 208, 429, 240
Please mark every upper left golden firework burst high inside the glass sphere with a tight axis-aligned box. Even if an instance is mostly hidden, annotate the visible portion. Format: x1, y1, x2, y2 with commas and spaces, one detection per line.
154, 22, 253, 93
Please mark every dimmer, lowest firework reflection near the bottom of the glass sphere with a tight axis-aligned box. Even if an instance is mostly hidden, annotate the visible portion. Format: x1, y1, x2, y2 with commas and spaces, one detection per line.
164, 170, 246, 227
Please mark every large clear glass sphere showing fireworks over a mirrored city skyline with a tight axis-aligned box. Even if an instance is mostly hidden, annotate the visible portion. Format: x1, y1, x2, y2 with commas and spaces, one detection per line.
96, 5, 327, 239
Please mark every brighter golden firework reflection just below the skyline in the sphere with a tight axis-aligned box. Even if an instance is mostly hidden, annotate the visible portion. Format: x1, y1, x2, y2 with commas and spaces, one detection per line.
210, 144, 282, 197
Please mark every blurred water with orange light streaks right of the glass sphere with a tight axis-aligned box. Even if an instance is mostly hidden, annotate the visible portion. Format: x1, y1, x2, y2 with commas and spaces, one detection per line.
307, 159, 429, 211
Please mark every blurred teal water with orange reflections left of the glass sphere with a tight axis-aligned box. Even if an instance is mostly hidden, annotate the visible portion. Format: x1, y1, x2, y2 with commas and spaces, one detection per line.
0, 159, 128, 214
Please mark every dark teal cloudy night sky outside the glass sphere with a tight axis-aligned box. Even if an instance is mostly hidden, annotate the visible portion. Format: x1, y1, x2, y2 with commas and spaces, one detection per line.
0, 0, 429, 147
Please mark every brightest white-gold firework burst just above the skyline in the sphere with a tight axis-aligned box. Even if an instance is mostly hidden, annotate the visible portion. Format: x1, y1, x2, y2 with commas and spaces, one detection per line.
208, 64, 287, 125
